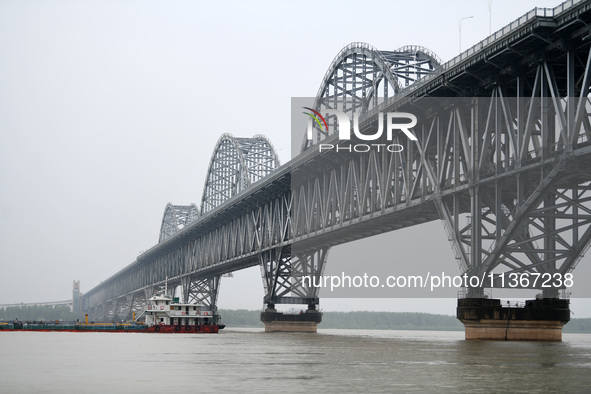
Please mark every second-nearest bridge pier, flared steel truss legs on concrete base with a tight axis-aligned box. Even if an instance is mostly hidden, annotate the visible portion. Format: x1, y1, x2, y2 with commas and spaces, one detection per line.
259, 247, 328, 333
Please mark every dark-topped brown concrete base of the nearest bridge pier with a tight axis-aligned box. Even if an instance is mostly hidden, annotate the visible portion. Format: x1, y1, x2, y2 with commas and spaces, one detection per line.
457, 298, 570, 342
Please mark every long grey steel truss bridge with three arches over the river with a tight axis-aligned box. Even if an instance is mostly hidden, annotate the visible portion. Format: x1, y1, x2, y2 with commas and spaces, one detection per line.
82, 1, 591, 326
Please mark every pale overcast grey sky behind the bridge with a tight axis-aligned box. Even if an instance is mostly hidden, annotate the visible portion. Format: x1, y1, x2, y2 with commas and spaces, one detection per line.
0, 0, 591, 314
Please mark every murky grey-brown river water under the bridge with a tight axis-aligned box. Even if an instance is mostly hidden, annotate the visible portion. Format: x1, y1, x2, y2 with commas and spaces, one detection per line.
0, 328, 591, 393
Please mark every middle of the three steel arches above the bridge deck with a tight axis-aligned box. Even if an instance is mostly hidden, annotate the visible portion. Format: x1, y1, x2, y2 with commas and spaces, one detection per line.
201, 134, 279, 214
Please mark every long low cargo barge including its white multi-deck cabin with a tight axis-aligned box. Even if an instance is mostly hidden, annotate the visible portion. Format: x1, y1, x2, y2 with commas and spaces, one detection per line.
0, 294, 225, 334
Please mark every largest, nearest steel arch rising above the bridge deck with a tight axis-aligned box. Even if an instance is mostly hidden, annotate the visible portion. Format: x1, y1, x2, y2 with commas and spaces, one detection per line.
302, 42, 442, 150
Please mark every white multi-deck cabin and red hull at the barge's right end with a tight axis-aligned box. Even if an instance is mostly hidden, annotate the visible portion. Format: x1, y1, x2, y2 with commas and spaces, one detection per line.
136, 293, 225, 334
